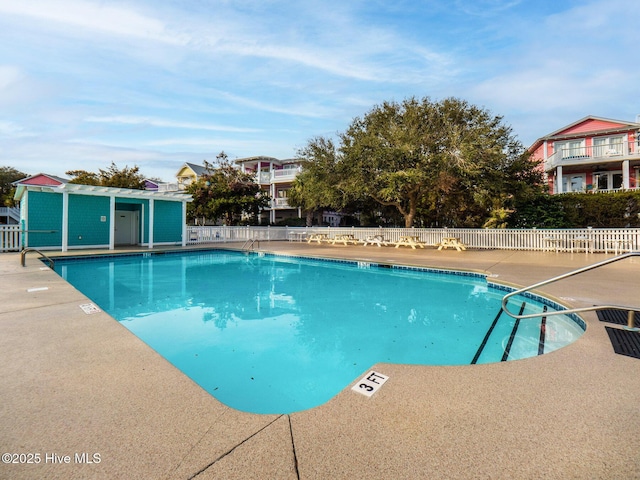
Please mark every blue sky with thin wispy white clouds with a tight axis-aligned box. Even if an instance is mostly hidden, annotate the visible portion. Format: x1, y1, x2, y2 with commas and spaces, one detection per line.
0, 0, 640, 181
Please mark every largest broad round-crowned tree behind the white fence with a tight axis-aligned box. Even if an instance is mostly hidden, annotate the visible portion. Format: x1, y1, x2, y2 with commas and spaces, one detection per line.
338, 98, 541, 227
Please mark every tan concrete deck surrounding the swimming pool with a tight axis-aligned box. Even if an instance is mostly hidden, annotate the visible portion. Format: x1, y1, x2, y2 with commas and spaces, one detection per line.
0, 242, 640, 480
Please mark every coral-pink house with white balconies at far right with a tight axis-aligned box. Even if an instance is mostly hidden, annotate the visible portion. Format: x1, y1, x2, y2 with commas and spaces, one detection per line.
529, 116, 640, 194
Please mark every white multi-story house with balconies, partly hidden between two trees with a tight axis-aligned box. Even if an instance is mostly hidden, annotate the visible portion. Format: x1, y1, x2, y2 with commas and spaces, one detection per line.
235, 156, 302, 224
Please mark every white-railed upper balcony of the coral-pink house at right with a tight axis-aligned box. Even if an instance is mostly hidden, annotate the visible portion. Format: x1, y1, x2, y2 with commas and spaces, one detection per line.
544, 142, 640, 171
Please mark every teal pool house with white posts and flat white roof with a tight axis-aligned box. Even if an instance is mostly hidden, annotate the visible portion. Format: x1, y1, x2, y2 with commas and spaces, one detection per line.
15, 174, 191, 252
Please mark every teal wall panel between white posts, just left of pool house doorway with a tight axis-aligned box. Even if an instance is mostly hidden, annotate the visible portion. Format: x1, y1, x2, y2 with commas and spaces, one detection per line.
69, 195, 109, 247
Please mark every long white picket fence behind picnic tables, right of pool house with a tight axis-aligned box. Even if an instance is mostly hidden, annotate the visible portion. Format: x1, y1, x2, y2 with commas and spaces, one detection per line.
187, 226, 640, 253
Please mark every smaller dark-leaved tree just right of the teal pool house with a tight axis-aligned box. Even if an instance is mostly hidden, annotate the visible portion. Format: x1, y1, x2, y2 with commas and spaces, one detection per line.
186, 157, 269, 225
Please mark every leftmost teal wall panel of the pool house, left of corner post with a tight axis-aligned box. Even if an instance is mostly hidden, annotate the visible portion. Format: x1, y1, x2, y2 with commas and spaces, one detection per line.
27, 192, 62, 248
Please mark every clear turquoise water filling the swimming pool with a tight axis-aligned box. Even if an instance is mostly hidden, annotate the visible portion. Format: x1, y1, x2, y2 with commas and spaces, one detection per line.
55, 250, 584, 413
